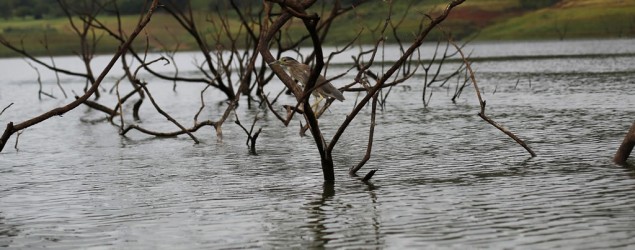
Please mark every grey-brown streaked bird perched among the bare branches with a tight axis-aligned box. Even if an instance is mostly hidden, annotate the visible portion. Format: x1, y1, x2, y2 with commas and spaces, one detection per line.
269, 56, 345, 109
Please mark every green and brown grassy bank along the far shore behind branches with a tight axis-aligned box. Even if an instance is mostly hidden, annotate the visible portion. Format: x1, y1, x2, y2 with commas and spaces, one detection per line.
0, 0, 635, 57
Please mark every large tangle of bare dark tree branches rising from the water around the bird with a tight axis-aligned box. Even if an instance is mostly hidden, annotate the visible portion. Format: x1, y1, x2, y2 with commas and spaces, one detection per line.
0, 0, 534, 181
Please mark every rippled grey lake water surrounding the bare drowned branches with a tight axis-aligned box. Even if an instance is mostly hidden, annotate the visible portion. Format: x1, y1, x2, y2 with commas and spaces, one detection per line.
0, 40, 635, 249
